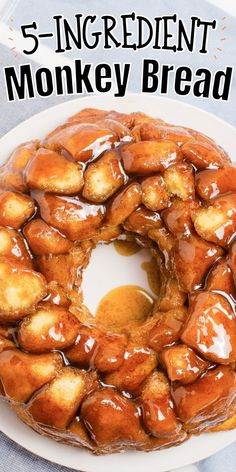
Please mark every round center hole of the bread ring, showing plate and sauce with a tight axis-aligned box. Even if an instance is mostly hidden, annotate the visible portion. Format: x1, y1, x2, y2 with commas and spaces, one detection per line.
82, 241, 155, 329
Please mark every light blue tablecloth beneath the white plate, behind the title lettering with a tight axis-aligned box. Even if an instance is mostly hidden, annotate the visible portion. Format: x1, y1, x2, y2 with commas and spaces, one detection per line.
0, 0, 236, 472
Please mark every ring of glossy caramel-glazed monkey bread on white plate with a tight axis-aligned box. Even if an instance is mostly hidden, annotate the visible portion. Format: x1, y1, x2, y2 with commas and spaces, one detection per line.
0, 109, 236, 454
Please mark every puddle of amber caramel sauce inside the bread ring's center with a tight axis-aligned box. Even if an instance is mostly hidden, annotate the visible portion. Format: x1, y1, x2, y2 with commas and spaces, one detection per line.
95, 285, 154, 329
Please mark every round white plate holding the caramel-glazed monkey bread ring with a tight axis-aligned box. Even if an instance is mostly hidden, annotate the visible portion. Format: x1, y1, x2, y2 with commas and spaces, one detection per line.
0, 94, 236, 472
